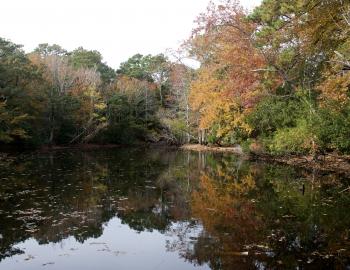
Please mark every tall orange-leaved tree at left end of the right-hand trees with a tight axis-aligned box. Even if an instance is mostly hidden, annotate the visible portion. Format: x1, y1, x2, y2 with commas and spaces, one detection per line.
189, 1, 266, 134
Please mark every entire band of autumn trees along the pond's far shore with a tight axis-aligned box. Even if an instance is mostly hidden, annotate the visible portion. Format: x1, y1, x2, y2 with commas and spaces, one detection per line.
0, 0, 350, 156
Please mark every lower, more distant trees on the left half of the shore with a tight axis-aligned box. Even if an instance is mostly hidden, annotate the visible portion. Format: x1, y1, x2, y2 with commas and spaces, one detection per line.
0, 39, 192, 146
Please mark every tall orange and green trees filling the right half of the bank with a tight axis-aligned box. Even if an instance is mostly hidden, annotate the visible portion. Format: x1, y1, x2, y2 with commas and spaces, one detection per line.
185, 0, 350, 154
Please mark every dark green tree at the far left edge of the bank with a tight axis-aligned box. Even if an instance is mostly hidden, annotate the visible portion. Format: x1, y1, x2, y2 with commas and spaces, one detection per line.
0, 38, 45, 146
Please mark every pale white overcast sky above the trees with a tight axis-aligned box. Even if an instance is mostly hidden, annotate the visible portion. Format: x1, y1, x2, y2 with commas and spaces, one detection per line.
0, 0, 261, 69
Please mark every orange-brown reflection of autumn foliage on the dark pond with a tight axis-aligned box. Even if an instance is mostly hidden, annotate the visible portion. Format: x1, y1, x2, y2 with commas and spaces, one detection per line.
191, 170, 260, 243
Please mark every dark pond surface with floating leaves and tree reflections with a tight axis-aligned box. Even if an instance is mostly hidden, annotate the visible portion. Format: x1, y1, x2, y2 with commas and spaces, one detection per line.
0, 149, 350, 270
